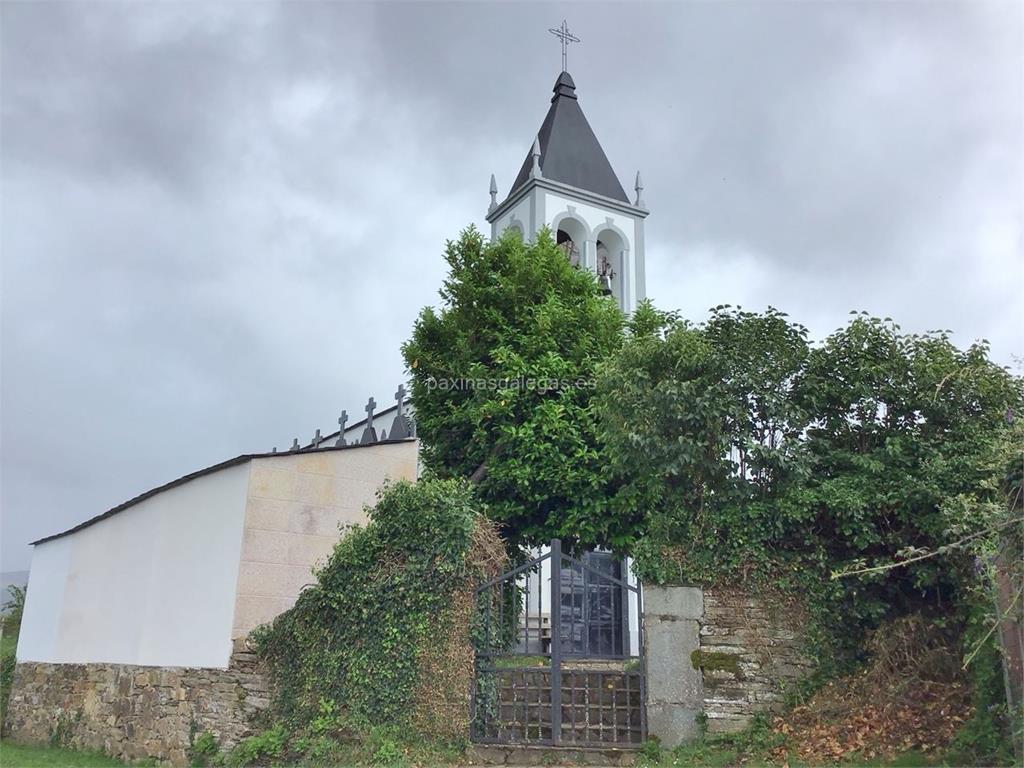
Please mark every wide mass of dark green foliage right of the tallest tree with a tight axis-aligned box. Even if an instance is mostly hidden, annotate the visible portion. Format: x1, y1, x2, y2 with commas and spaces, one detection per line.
596, 306, 1021, 637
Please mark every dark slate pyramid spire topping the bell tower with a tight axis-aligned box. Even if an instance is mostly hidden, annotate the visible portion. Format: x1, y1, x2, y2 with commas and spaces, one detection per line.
510, 72, 630, 203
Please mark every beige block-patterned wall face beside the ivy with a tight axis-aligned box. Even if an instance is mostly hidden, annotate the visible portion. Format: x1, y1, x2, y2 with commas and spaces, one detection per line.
231, 438, 419, 637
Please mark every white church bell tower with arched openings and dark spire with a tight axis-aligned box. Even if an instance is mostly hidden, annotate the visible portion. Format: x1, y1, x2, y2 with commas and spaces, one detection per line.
487, 71, 648, 312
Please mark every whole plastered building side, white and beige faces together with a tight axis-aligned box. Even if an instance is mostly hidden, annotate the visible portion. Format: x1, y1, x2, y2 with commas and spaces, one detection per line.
17, 440, 419, 668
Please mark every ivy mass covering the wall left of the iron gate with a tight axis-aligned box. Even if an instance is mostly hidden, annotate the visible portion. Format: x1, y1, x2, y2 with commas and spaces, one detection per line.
248, 479, 505, 728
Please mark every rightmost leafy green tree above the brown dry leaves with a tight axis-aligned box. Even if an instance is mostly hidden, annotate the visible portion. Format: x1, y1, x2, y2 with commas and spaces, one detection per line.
794, 315, 1021, 611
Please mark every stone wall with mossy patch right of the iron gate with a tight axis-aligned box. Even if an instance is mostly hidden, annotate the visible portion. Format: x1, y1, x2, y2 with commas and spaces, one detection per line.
644, 587, 812, 746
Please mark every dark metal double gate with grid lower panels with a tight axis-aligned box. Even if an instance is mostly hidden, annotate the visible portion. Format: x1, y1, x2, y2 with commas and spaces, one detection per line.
470, 540, 647, 746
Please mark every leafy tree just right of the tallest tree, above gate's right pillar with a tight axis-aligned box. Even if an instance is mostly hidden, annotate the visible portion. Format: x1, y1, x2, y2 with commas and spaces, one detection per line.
596, 304, 808, 580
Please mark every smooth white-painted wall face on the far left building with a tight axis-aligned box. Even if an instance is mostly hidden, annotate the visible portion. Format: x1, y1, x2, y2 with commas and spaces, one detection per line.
17, 463, 250, 667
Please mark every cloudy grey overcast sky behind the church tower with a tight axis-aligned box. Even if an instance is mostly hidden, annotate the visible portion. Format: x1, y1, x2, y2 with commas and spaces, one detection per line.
0, 1, 1024, 570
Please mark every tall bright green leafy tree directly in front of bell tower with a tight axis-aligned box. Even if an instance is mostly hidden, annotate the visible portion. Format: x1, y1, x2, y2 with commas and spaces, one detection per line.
402, 228, 630, 546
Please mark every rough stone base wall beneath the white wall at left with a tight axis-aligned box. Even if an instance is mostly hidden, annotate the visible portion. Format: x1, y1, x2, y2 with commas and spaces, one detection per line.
5, 643, 269, 765
